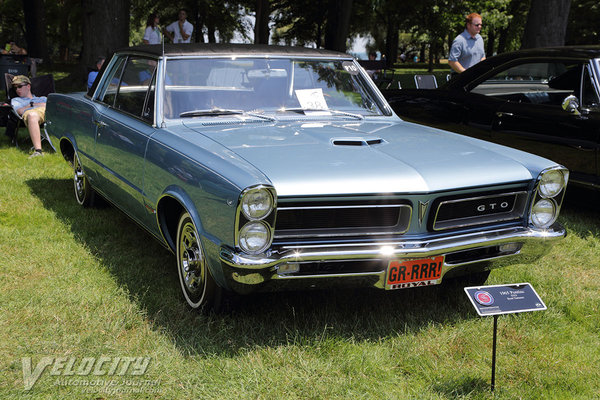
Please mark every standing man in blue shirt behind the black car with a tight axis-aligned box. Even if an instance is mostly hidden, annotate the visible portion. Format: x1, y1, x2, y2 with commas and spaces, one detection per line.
448, 13, 485, 73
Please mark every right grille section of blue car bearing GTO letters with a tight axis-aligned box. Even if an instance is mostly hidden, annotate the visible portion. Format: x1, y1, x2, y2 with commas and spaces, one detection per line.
429, 190, 528, 231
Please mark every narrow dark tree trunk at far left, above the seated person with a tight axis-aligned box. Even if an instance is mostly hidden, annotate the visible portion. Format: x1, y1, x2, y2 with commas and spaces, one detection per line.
23, 0, 50, 62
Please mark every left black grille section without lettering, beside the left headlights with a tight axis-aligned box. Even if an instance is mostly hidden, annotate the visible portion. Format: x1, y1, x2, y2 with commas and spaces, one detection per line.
275, 198, 411, 238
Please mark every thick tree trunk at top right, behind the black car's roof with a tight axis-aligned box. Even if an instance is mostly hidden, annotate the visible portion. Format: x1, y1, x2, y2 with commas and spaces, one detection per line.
521, 0, 571, 49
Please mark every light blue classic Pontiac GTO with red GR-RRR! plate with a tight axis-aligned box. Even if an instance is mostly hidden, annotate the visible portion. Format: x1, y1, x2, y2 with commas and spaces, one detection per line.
46, 44, 568, 309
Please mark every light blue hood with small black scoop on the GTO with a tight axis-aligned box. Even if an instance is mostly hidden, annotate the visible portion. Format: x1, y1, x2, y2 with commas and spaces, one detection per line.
186, 121, 548, 196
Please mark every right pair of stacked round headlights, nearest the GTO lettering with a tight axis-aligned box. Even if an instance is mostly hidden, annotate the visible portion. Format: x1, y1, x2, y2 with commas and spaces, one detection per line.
529, 167, 569, 228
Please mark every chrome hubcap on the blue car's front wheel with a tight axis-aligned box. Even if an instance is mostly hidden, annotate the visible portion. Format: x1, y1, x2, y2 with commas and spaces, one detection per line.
179, 222, 204, 293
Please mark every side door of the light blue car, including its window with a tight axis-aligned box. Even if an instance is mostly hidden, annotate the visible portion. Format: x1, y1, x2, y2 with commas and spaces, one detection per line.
94, 56, 156, 224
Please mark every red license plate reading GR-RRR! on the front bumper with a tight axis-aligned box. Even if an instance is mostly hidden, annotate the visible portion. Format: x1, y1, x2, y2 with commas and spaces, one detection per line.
385, 256, 444, 289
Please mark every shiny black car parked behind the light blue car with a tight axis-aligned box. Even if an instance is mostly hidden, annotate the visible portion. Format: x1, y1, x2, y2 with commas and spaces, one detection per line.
384, 46, 600, 189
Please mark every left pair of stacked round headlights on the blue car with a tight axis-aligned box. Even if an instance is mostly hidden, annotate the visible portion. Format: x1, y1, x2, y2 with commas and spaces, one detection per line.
235, 185, 277, 255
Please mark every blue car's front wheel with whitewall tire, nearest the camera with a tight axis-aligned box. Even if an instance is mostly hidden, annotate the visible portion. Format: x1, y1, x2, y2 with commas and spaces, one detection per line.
177, 212, 222, 310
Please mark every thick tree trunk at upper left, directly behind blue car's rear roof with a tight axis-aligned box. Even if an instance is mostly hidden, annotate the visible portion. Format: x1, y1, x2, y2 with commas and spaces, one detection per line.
81, 0, 130, 66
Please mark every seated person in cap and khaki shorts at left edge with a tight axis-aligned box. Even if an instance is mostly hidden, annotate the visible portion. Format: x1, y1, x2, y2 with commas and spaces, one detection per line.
10, 75, 47, 158
